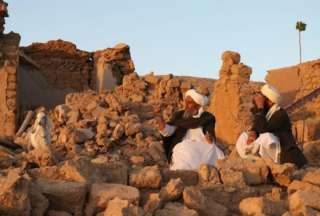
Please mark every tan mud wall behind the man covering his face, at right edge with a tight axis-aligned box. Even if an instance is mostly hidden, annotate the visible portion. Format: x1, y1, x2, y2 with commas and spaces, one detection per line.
266, 59, 320, 154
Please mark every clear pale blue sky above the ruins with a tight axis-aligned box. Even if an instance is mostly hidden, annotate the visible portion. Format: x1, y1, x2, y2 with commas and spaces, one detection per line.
6, 0, 320, 80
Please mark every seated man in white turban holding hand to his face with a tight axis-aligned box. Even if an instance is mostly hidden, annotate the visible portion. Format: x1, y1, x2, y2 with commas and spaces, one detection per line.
236, 84, 307, 167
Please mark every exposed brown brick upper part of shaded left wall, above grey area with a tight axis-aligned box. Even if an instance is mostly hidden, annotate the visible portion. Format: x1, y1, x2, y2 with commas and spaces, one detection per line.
21, 40, 92, 91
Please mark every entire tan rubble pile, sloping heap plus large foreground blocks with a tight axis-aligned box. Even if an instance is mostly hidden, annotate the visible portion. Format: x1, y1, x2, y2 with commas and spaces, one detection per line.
0, 70, 320, 216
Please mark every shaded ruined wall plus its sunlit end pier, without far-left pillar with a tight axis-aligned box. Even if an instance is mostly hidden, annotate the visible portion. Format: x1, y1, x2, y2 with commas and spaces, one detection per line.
19, 40, 134, 109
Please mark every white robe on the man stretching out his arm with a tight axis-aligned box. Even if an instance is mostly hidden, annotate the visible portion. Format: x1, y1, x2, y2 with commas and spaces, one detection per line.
170, 127, 224, 170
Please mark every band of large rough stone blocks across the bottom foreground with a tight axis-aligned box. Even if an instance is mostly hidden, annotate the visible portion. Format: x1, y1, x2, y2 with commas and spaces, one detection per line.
0, 142, 320, 216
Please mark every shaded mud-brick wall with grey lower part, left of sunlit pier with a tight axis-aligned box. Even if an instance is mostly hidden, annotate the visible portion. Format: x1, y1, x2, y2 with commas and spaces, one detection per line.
19, 40, 92, 110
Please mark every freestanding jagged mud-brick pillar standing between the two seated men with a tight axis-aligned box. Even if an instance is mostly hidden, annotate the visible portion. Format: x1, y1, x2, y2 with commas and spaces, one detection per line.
209, 51, 255, 147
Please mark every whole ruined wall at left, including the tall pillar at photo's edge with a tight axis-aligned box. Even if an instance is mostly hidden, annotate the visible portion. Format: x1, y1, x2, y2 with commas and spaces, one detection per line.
0, 0, 134, 137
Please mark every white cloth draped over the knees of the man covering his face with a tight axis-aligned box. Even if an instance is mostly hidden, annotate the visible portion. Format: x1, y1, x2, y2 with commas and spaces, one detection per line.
236, 132, 281, 163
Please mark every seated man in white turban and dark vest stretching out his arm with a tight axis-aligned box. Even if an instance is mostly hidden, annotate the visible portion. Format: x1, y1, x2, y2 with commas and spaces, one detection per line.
158, 89, 224, 170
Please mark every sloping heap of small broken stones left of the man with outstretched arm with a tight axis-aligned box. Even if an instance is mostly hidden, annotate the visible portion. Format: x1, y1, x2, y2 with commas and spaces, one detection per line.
12, 73, 198, 165
